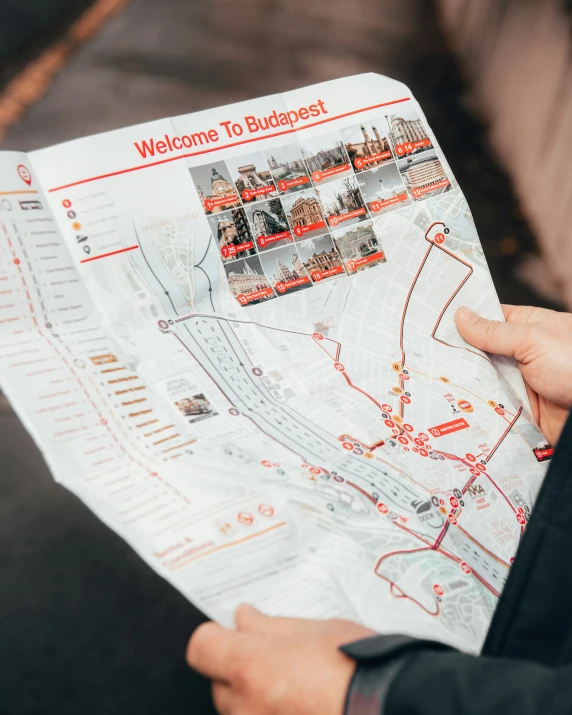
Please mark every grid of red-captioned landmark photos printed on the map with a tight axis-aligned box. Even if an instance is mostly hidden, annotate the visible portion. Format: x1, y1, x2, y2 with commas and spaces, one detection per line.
189, 106, 452, 306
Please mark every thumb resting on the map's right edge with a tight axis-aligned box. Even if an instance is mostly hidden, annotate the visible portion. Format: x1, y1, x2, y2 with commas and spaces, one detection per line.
455, 307, 529, 357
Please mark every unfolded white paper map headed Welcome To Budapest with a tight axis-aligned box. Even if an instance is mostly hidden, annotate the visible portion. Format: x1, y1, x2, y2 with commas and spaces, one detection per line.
0, 74, 552, 652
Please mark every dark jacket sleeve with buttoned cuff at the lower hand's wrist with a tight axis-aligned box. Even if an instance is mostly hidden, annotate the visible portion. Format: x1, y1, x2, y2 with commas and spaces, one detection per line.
342, 636, 572, 715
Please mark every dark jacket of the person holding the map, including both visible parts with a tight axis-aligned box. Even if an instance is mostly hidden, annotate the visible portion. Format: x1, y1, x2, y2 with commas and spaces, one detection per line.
342, 416, 572, 715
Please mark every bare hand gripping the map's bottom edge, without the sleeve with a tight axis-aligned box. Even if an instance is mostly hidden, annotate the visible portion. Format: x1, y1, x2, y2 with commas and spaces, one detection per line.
187, 606, 375, 715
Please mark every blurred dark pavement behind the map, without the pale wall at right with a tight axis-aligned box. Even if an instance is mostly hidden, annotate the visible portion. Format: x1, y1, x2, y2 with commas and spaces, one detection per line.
0, 0, 564, 715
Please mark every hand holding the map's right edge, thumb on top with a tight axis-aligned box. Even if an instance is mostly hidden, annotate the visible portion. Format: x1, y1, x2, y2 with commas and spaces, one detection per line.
455, 305, 572, 445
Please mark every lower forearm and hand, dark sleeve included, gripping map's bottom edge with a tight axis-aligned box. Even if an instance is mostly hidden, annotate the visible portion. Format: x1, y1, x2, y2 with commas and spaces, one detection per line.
187, 607, 572, 715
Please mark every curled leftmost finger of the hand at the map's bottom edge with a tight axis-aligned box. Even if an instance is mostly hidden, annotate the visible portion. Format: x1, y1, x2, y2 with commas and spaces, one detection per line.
187, 623, 242, 682
